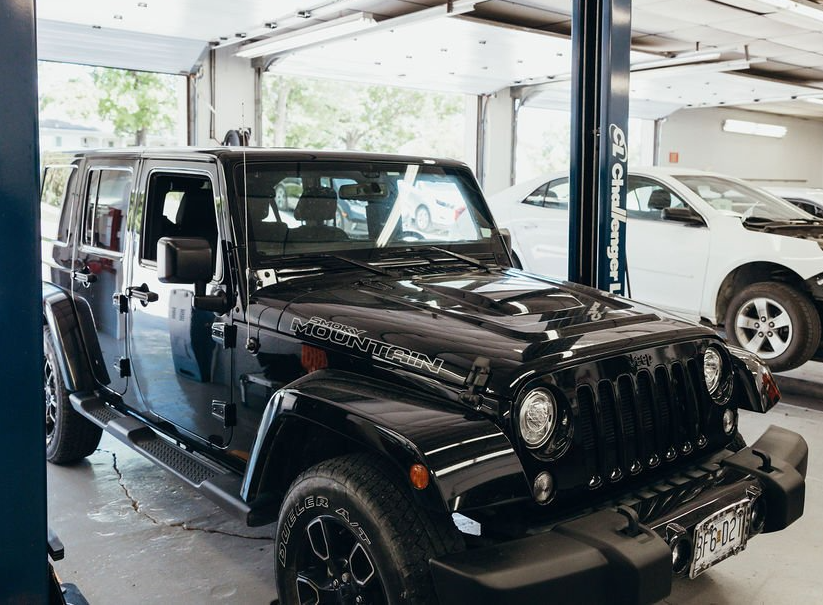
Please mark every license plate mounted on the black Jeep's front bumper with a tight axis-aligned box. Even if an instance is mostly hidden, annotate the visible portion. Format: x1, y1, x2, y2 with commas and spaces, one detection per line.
689, 500, 749, 578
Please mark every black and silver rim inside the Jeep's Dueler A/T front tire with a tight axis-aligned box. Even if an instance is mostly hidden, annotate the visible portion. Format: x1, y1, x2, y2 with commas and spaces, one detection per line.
295, 516, 388, 605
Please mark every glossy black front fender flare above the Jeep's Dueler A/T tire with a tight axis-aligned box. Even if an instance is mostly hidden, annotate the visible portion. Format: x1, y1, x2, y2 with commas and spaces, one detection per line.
241, 370, 531, 523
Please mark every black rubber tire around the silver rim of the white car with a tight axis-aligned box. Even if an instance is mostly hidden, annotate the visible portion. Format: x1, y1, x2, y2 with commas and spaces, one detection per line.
725, 282, 821, 372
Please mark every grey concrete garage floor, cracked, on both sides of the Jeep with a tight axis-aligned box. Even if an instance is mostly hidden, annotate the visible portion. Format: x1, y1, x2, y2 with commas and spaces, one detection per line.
48, 364, 823, 605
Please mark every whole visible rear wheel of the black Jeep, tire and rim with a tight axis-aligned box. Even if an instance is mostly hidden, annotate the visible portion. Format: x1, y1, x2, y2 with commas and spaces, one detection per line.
43, 328, 103, 464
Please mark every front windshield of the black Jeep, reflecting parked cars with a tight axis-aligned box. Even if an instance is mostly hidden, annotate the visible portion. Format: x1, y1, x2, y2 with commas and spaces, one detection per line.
233, 161, 492, 265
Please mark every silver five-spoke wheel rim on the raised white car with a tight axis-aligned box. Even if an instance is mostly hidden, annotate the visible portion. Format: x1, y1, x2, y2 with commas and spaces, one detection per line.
734, 297, 794, 359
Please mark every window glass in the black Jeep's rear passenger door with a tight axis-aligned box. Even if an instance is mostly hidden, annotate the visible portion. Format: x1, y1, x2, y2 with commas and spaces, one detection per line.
83, 169, 132, 252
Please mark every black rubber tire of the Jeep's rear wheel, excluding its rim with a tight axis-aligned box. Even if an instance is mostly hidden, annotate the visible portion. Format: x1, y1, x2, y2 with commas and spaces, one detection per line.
43, 328, 103, 464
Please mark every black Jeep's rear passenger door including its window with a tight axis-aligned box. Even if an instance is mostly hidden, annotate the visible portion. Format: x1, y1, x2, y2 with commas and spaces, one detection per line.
71, 158, 136, 395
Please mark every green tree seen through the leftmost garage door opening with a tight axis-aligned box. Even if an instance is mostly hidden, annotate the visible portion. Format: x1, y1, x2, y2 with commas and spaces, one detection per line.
92, 68, 176, 145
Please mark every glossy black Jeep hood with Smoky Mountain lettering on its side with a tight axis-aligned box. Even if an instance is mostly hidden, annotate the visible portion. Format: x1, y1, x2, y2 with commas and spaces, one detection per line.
255, 269, 713, 394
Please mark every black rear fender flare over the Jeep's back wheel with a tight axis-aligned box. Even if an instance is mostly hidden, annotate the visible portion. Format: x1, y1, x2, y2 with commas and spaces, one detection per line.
43, 283, 111, 392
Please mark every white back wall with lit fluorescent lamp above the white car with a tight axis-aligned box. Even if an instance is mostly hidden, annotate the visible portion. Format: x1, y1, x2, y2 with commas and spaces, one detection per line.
659, 108, 823, 187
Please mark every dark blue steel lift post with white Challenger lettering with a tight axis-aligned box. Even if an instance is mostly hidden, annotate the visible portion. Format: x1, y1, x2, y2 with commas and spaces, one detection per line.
569, 0, 631, 294
